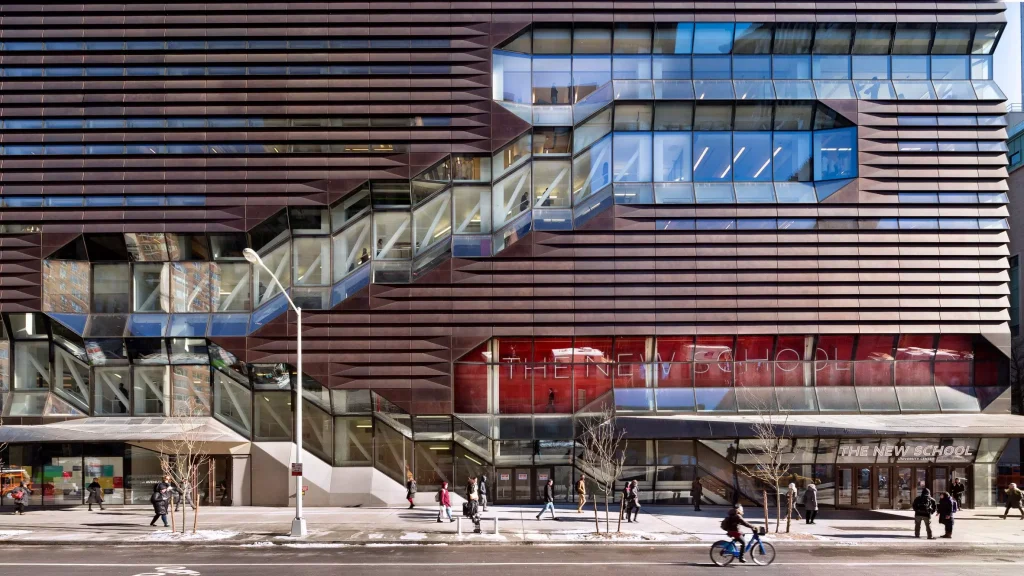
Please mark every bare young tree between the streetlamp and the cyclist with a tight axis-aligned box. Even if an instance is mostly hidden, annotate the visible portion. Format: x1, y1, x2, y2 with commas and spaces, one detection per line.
580, 406, 627, 534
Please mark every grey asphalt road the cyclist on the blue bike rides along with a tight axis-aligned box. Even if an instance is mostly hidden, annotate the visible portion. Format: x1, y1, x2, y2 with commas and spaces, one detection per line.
0, 545, 1024, 576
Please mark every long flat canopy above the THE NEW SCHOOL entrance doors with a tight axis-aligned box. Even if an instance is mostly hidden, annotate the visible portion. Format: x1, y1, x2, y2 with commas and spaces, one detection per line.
615, 414, 1024, 440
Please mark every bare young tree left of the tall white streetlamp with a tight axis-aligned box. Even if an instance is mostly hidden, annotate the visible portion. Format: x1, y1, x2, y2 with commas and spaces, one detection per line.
160, 399, 210, 534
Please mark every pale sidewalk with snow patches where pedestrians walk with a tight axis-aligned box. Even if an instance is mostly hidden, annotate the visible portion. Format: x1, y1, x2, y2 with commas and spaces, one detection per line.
0, 505, 1024, 547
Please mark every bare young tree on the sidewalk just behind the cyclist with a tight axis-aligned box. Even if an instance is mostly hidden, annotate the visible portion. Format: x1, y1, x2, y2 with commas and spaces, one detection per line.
740, 395, 793, 534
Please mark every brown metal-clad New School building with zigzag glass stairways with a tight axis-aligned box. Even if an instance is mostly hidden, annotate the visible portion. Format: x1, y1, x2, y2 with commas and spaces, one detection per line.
0, 2, 1024, 508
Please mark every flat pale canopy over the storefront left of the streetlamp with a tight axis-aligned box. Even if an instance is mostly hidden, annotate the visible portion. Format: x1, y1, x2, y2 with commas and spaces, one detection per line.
0, 417, 249, 445
